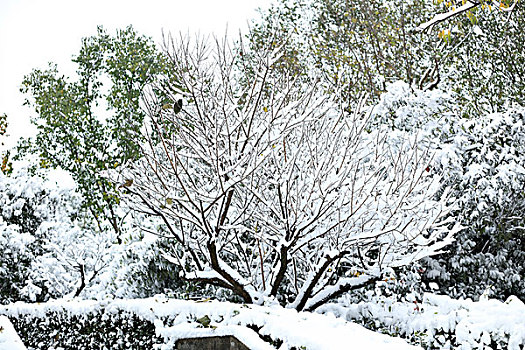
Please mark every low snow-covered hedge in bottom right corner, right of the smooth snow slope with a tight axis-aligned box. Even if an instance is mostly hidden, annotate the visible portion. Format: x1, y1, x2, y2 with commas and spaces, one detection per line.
318, 293, 525, 350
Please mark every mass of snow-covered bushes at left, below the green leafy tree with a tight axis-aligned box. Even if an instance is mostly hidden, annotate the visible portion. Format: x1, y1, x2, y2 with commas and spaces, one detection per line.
0, 166, 180, 303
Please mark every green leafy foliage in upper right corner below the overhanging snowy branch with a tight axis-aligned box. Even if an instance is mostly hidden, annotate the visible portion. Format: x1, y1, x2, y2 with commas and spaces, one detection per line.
442, 6, 525, 115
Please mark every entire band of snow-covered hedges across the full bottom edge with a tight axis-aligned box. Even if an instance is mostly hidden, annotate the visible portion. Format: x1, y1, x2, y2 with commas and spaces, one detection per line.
4, 293, 525, 350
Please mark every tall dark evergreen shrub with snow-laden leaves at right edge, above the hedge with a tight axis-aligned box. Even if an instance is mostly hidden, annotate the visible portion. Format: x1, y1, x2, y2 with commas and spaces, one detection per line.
425, 109, 525, 300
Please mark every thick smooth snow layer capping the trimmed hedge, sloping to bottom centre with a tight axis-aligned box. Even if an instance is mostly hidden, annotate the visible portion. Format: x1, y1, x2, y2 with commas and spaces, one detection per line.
0, 296, 418, 350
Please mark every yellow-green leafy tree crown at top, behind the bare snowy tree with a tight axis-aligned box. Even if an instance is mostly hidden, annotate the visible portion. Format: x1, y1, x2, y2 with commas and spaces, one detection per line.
251, 0, 444, 101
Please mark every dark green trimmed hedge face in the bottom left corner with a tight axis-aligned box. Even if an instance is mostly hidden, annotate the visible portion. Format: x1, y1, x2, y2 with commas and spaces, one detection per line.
4, 303, 159, 350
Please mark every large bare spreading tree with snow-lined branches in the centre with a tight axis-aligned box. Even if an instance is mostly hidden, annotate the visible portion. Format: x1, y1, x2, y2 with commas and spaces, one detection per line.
120, 34, 458, 310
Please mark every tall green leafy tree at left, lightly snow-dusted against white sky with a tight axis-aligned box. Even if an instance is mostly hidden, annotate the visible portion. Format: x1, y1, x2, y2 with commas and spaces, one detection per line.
18, 27, 165, 238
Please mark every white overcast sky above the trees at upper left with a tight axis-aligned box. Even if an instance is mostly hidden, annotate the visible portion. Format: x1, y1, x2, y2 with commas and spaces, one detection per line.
0, 0, 271, 146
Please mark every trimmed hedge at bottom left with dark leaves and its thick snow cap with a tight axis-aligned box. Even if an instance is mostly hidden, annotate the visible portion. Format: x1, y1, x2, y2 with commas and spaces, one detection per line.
0, 296, 416, 350
